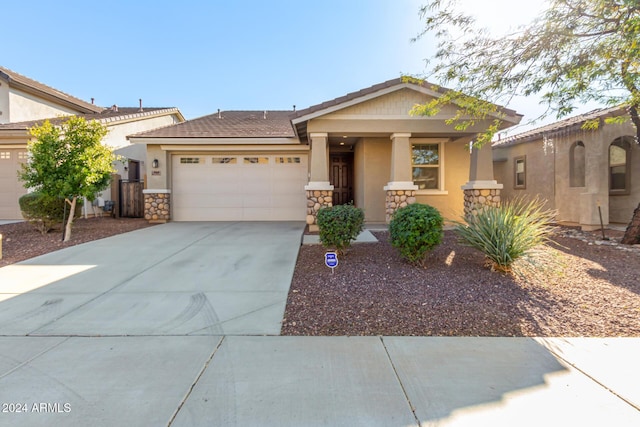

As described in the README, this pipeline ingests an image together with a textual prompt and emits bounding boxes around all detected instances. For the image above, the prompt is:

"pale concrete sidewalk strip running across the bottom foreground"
[0,336,640,427]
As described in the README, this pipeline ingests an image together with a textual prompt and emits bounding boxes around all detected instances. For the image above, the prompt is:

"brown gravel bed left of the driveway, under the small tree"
[0,217,155,267]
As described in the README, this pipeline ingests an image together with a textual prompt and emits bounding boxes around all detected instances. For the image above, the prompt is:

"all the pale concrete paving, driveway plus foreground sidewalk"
[0,222,640,427]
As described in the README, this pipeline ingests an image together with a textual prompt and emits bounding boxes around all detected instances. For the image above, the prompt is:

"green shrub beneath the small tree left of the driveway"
[18,192,82,234]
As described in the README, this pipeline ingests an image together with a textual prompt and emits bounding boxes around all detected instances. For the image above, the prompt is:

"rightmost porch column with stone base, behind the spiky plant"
[462,143,503,218]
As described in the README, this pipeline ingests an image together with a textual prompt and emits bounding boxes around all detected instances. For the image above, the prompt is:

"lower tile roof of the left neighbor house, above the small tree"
[0,107,182,131]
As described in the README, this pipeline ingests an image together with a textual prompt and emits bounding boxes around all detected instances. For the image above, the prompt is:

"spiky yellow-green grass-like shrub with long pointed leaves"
[455,198,555,272]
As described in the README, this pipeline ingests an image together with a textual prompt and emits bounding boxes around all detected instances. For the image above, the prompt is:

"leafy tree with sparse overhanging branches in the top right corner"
[412,0,640,242]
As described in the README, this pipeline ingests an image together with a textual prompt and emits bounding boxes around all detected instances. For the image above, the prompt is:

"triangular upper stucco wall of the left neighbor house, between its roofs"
[7,84,78,123]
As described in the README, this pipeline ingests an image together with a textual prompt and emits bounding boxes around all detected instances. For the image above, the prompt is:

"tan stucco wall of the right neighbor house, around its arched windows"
[493,119,640,225]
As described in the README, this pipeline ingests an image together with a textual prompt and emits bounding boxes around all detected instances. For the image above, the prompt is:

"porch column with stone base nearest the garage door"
[304,133,333,231]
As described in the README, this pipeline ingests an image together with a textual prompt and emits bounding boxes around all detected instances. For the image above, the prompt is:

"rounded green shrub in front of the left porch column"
[318,204,364,253]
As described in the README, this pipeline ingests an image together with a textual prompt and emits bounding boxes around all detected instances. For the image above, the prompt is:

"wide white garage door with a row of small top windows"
[171,154,307,221]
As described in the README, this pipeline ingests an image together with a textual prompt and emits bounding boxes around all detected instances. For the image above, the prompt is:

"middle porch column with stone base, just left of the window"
[384,133,418,223]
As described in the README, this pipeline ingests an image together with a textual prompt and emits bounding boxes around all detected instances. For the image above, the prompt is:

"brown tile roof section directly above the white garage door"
[133,110,296,138]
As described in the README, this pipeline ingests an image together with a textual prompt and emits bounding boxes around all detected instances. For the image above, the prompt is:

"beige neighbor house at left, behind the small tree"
[0,67,184,219]
